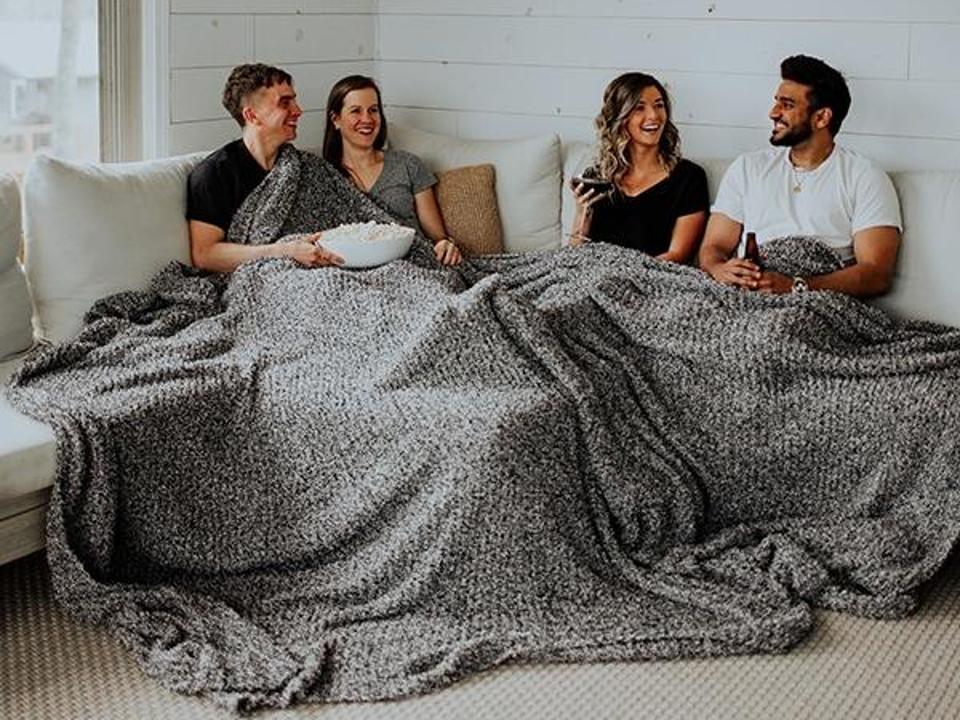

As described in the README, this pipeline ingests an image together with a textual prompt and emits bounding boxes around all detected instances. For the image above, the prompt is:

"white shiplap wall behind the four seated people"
[169,0,960,169]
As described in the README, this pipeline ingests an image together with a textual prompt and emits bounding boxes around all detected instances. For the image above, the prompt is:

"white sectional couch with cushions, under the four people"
[0,127,960,563]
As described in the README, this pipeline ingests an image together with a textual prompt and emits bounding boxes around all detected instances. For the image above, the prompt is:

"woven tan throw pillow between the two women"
[436,164,503,255]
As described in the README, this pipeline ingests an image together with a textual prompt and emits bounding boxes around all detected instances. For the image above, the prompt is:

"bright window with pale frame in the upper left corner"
[0,0,149,175]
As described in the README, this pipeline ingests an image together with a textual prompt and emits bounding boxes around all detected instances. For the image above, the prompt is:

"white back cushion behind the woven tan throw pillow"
[390,125,560,252]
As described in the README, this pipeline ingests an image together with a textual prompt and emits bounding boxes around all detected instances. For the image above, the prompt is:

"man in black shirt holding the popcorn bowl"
[187,63,343,272]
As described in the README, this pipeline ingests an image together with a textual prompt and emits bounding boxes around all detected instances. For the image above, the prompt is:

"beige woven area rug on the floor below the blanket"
[0,553,960,720]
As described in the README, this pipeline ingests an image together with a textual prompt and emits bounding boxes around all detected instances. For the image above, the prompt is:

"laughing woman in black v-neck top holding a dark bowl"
[570,73,710,263]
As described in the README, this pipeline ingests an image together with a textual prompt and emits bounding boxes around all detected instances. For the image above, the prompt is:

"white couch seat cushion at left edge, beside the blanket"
[0,361,57,502]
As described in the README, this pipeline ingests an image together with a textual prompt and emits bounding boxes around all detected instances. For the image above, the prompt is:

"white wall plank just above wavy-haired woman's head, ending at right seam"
[379,15,909,78]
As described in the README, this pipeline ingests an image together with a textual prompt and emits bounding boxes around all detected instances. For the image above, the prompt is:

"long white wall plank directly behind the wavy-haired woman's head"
[379,62,960,140]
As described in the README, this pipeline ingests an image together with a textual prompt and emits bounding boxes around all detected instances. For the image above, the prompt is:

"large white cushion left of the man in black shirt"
[24,154,202,341]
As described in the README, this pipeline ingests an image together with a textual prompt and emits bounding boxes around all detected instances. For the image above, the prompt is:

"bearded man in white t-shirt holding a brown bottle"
[700,55,901,296]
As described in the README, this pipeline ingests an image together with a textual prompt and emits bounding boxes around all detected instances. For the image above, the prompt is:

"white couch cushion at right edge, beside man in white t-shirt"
[876,170,960,327]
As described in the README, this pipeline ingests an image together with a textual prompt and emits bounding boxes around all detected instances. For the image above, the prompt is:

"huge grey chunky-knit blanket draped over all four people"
[9,148,960,711]
